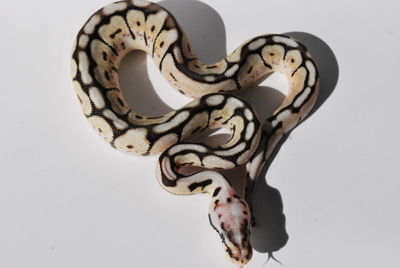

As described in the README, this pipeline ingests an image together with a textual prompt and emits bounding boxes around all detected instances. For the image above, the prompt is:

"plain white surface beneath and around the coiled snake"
[0,0,400,268]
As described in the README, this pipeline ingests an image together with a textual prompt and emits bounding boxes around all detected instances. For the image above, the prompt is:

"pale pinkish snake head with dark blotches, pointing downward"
[209,195,252,265]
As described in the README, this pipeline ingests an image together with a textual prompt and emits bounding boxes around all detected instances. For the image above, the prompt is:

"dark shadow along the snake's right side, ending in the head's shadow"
[250,32,339,253]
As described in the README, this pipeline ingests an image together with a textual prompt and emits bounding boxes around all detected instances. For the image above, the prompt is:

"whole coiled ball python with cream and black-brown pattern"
[71,0,319,265]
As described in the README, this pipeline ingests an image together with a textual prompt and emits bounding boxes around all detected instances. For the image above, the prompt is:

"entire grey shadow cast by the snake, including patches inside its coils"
[119,0,339,260]
